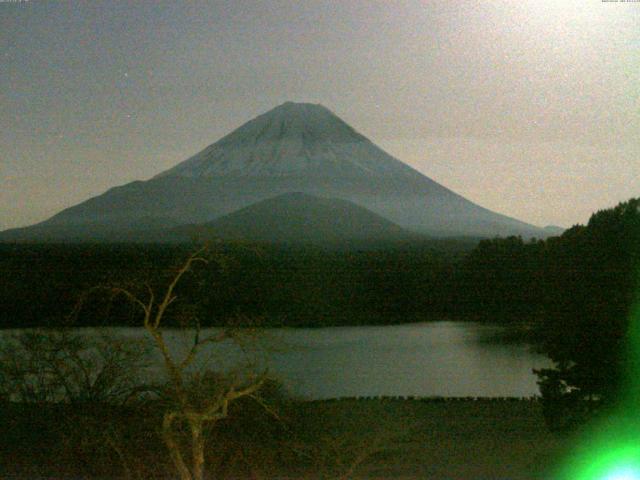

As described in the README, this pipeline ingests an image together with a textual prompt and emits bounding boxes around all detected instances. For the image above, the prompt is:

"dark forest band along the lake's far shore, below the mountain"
[0,241,474,328]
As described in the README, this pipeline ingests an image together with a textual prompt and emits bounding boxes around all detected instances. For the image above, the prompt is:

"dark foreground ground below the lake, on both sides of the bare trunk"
[0,399,567,480]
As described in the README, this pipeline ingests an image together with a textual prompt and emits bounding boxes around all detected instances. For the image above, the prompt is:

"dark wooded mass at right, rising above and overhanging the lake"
[450,199,640,430]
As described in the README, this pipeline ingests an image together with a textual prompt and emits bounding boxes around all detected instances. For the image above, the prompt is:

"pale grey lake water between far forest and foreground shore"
[0,322,549,399]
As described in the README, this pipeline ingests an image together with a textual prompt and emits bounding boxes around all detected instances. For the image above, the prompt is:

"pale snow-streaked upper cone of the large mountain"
[158,102,420,177]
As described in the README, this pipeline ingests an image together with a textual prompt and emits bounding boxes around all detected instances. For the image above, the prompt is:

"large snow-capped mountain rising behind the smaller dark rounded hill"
[0,102,548,241]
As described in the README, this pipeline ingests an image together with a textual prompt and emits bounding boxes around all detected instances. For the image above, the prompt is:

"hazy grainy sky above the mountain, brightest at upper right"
[0,0,640,229]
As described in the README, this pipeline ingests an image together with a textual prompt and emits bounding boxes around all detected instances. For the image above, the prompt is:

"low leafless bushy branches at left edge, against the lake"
[0,328,146,404]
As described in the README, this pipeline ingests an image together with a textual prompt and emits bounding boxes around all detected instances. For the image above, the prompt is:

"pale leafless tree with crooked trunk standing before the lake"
[112,247,266,480]
